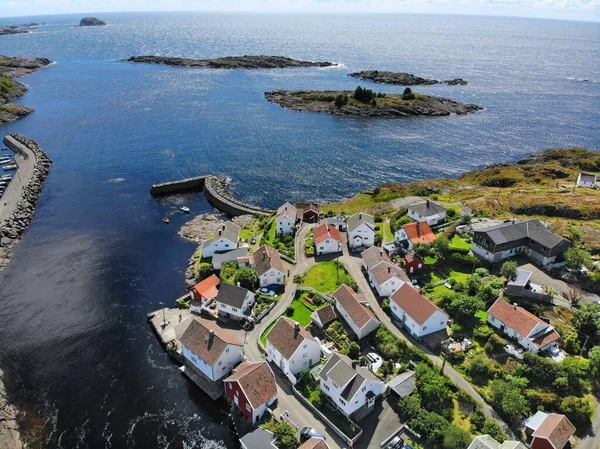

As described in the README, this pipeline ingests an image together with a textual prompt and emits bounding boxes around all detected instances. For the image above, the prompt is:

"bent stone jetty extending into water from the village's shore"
[150,175,275,217]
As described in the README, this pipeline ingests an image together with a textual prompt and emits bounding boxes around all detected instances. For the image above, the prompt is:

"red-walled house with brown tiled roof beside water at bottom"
[223,361,277,423]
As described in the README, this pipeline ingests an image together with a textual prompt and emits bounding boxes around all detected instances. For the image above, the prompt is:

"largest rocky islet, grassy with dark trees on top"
[265,86,483,118]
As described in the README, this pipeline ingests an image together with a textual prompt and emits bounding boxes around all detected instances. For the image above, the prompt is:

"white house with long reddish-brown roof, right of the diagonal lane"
[390,284,448,339]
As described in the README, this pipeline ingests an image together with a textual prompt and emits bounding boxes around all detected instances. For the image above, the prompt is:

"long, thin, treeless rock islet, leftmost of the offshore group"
[126,55,336,69]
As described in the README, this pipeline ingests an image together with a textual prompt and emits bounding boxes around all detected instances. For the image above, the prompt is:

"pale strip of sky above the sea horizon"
[0,0,600,22]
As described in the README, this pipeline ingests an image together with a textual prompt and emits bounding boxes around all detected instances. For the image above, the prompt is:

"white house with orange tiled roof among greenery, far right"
[487,298,560,354]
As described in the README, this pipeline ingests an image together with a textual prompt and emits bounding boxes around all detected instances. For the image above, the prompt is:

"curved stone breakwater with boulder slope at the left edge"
[0,134,52,270]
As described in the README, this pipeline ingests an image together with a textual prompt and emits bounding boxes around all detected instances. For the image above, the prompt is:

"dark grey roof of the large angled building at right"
[478,219,566,248]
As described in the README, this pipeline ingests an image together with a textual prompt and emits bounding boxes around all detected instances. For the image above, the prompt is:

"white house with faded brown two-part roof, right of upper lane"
[361,246,410,298]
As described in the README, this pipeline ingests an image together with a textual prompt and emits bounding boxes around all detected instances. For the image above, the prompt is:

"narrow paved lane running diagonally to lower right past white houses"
[340,245,512,434]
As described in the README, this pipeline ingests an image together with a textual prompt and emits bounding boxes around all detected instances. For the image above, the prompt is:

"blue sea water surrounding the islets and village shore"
[0,13,600,448]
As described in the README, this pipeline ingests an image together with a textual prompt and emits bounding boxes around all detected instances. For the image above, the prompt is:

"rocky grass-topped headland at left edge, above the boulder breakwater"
[0,55,52,125]
